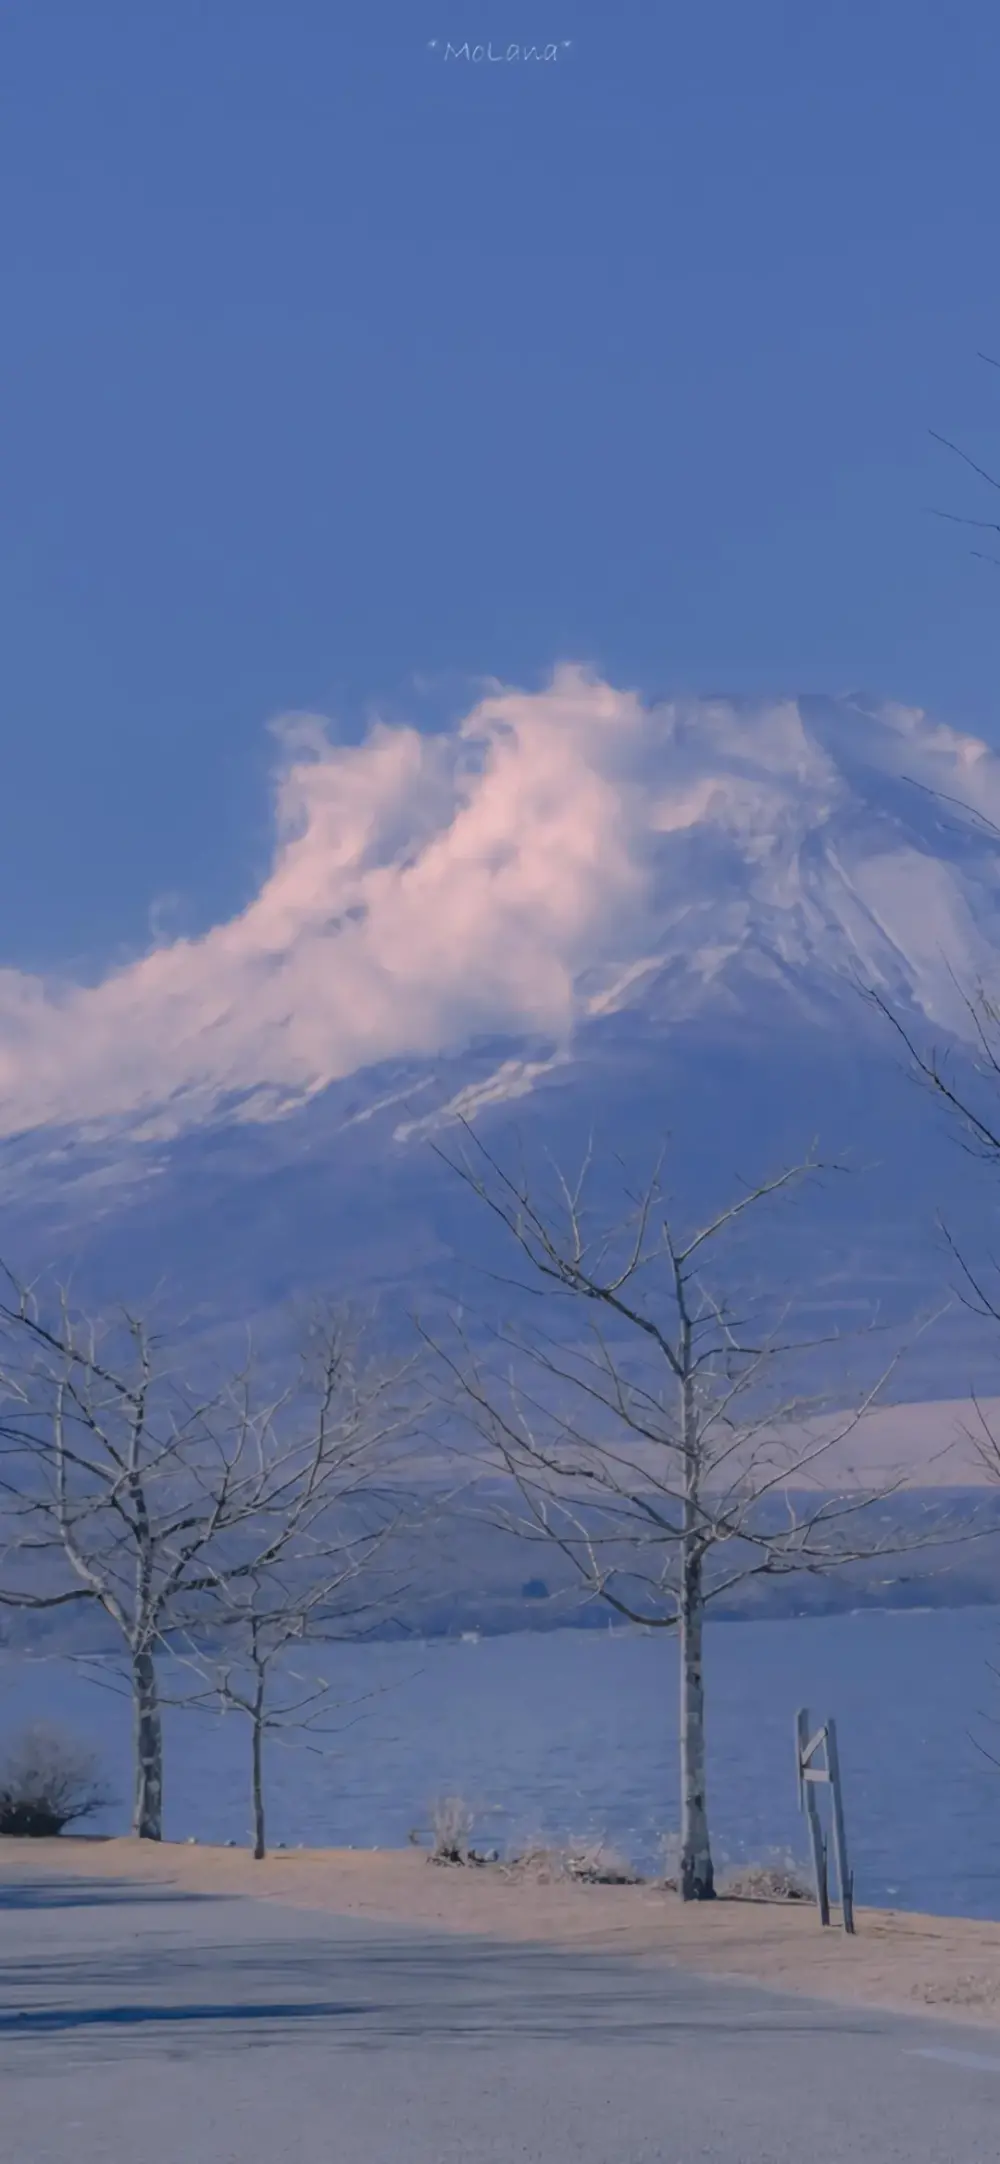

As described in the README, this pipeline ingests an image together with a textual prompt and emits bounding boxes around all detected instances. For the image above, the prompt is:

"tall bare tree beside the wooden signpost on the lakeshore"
[424,1127,942,1900]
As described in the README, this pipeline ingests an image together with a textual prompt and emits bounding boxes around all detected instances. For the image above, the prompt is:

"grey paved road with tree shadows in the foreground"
[0,1872,1000,2164]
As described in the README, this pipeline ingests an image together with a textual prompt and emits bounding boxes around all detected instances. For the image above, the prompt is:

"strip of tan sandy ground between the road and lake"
[0,1835,1000,2028]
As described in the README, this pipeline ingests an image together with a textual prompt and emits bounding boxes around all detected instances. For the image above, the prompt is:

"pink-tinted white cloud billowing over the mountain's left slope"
[0,669,658,1134]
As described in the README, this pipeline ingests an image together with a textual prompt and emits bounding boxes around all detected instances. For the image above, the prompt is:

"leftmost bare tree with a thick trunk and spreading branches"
[0,1272,422,1839]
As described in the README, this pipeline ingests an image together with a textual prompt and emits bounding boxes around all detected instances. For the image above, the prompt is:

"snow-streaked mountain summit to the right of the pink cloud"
[567,699,1000,1030]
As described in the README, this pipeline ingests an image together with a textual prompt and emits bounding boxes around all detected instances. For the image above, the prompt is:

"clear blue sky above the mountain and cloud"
[0,0,1000,974]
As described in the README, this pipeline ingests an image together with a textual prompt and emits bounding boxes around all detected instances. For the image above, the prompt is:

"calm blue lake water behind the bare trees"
[0,1608,1000,1917]
